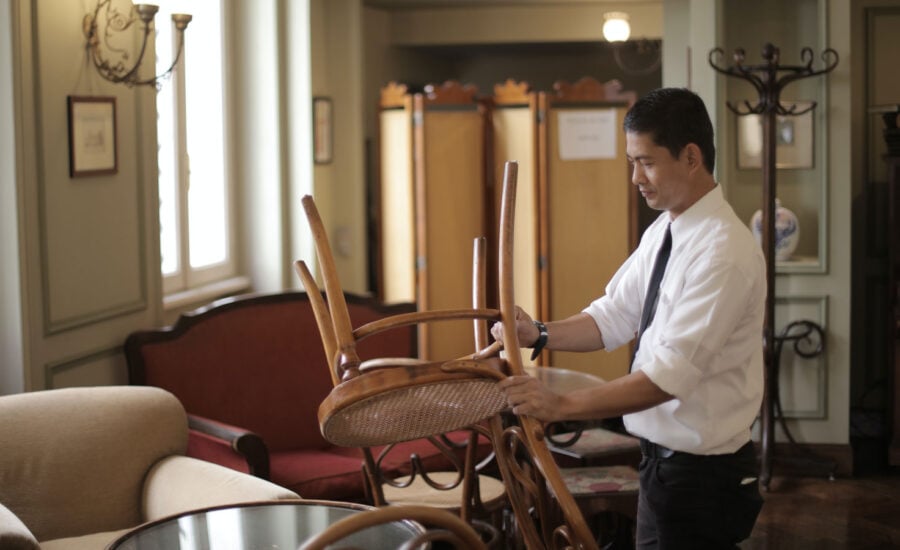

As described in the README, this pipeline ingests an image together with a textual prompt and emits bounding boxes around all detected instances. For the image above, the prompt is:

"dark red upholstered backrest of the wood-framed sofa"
[125,291,415,452]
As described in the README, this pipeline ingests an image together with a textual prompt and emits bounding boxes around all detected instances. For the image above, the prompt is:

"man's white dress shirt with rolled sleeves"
[584,185,766,454]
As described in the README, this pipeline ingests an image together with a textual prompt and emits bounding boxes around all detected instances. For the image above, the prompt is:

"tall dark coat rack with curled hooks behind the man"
[709,43,838,489]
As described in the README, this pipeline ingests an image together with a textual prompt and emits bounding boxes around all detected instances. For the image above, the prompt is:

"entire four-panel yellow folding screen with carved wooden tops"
[379,78,637,379]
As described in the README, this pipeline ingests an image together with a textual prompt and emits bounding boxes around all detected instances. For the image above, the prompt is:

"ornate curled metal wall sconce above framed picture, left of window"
[82,0,192,89]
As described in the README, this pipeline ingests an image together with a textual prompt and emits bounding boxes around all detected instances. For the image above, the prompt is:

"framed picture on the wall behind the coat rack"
[737,101,815,169]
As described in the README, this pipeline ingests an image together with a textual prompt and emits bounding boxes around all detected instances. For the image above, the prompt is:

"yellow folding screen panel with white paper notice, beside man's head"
[538,79,637,380]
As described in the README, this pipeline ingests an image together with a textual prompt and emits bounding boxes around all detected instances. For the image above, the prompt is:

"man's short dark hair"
[622,88,716,174]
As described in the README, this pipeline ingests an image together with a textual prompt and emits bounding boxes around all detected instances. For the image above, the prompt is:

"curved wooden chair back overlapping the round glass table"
[300,506,487,550]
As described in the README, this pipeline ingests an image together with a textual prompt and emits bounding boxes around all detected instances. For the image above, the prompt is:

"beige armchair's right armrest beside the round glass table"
[142,456,300,521]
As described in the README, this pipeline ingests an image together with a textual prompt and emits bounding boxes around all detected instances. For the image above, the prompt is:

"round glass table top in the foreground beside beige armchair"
[108,500,423,550]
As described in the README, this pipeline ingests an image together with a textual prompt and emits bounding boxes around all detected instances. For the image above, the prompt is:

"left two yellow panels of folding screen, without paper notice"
[379,82,488,359]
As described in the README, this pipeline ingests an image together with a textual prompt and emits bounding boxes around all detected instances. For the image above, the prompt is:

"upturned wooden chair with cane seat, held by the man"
[296,168,515,447]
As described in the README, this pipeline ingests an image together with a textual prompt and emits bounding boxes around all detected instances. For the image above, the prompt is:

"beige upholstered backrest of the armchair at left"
[0,386,188,541]
